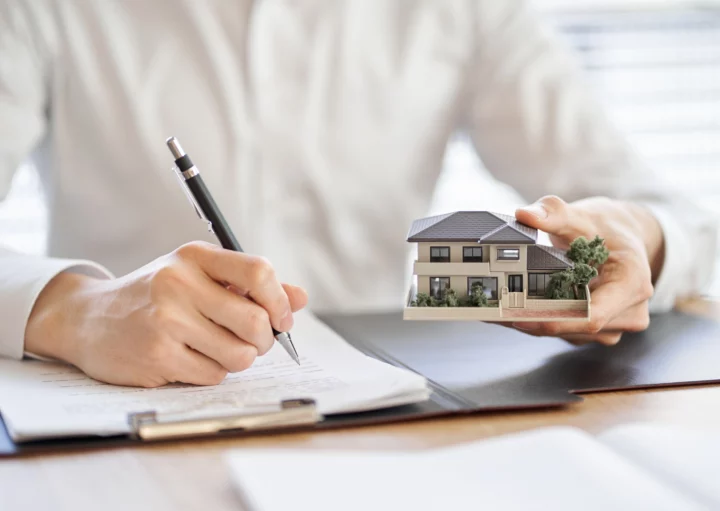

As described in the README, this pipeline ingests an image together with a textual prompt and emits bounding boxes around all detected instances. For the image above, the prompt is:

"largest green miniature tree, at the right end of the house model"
[545,236,610,300]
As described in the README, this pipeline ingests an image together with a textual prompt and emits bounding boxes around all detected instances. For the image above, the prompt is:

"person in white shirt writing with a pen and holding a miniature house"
[0,0,717,386]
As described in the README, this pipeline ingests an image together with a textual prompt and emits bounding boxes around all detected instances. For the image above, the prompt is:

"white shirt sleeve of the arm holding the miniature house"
[465,0,718,312]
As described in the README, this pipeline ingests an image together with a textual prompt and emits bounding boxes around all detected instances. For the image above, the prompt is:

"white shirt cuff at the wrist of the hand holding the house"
[645,204,693,313]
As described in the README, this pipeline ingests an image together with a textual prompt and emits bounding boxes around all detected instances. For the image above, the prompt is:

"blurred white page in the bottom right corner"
[599,423,720,509]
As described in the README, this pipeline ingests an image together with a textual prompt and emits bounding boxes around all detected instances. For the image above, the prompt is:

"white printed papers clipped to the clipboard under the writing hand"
[0,313,429,441]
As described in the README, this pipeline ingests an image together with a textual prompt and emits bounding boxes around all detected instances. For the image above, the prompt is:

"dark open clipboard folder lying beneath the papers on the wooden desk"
[0,312,720,456]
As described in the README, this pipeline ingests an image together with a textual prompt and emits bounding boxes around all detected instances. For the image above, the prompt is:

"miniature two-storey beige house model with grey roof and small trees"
[403,211,608,322]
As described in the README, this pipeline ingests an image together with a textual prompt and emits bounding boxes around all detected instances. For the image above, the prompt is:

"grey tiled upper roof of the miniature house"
[407,211,537,244]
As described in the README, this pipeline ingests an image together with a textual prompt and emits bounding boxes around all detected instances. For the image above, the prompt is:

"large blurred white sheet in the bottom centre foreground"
[228,428,705,511]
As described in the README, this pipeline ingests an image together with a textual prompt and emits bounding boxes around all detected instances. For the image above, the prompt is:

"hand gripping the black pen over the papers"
[25,151,307,387]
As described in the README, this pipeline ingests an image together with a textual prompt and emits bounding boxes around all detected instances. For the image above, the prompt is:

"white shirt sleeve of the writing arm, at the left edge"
[0,0,110,358]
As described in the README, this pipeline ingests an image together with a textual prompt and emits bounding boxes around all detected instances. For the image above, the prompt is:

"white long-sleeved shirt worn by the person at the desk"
[0,0,716,357]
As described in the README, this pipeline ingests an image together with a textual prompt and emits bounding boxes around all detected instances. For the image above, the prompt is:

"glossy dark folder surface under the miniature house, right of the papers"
[323,312,720,404]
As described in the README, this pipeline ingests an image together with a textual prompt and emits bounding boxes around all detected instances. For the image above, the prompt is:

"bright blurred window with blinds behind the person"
[0,0,720,297]
